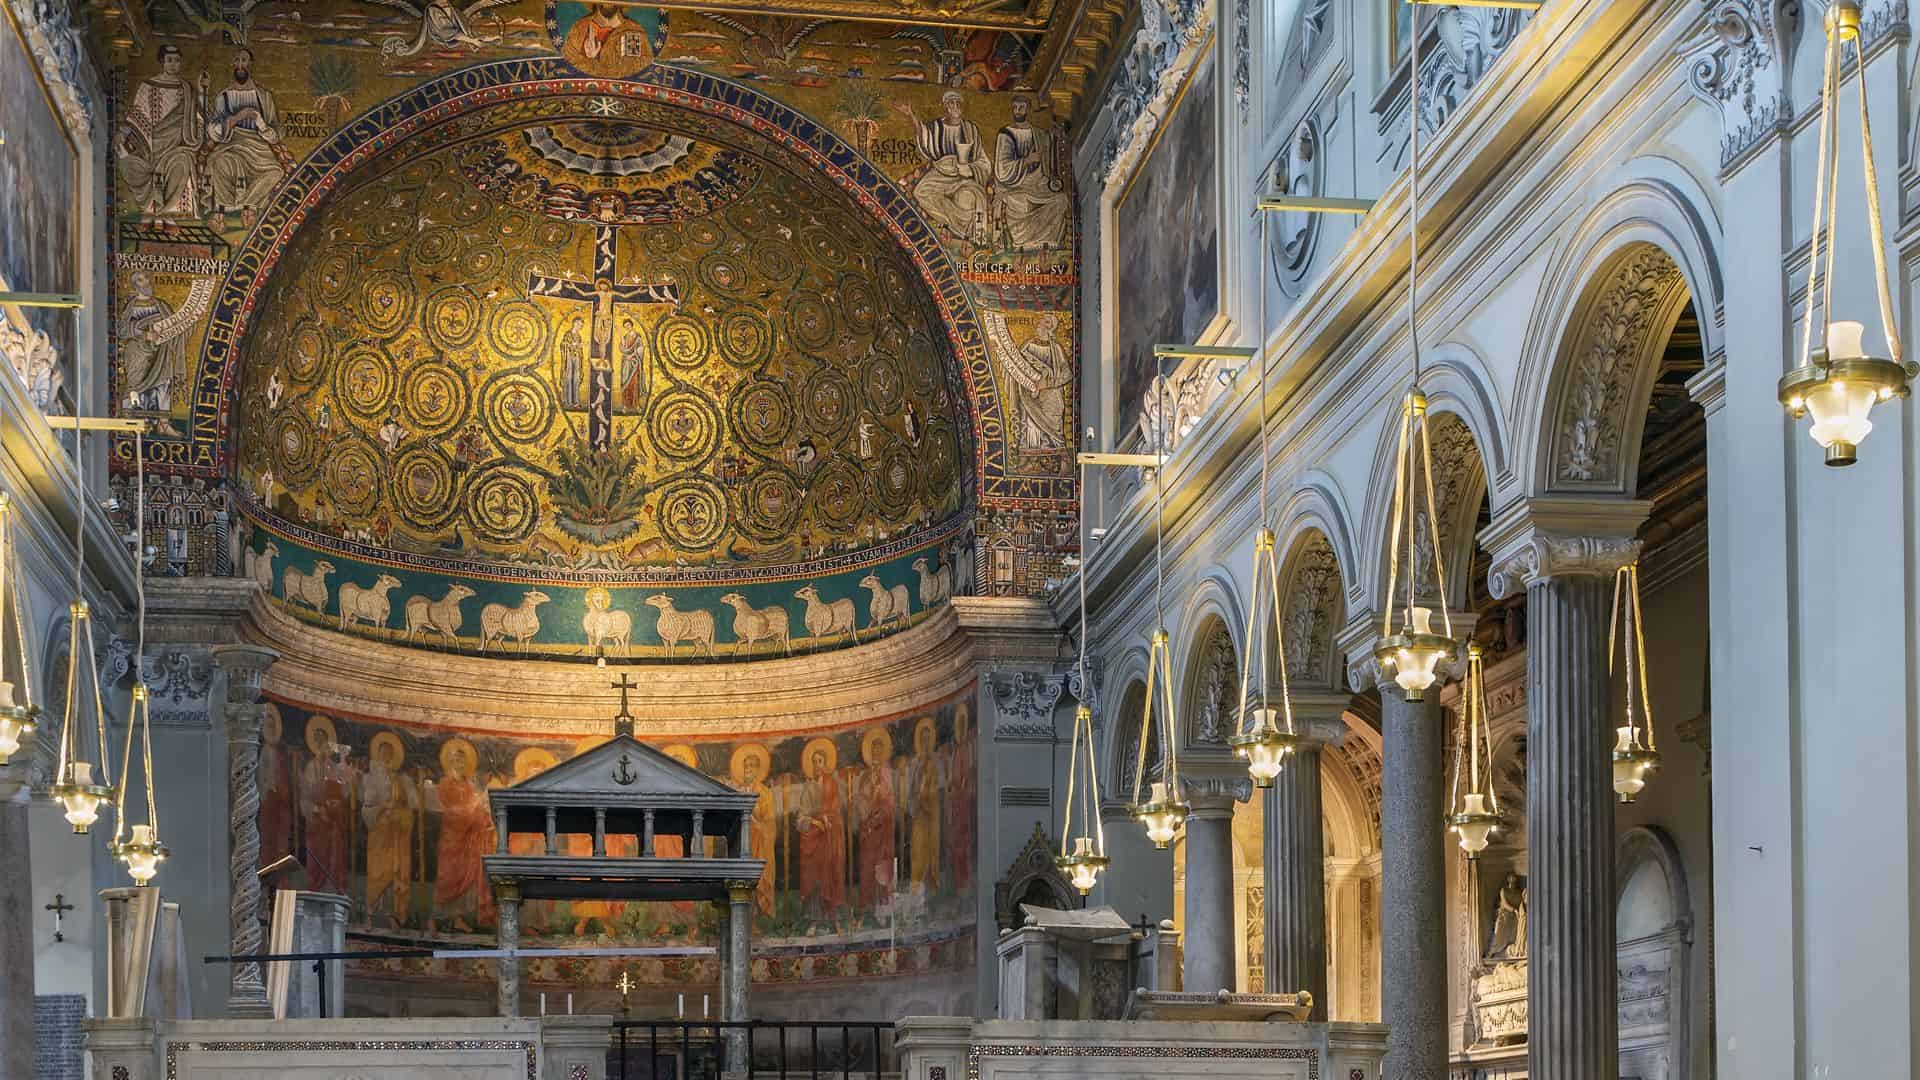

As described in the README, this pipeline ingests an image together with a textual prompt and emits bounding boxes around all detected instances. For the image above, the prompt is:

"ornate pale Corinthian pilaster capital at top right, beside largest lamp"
[1680,0,1801,171]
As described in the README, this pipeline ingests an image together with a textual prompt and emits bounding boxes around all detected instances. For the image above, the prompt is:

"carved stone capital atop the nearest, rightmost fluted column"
[1480,496,1653,600]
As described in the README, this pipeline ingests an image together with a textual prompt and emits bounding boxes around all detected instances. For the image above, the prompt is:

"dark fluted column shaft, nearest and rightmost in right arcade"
[1526,575,1620,1080]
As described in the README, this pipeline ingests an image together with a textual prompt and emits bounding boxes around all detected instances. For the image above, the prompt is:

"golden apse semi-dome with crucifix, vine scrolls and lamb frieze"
[234,96,970,659]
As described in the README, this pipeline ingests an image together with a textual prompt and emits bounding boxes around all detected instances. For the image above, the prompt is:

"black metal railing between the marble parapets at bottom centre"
[607,1020,899,1080]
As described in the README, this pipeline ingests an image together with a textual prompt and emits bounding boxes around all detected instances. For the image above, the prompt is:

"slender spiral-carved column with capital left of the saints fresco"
[213,646,280,1019]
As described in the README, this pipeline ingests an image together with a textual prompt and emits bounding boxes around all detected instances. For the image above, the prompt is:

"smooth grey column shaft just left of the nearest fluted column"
[1380,668,1443,1080]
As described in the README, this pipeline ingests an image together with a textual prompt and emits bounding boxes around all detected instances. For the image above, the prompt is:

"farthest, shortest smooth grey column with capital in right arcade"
[1181,773,1254,994]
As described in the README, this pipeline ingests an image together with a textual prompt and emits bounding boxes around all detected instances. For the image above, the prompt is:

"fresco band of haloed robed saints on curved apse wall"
[259,686,977,986]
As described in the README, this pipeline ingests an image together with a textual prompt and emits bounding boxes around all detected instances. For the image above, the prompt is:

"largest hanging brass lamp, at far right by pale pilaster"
[1780,0,1920,467]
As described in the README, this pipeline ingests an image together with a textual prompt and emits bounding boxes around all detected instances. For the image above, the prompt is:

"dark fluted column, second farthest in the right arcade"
[1261,701,1346,1022]
